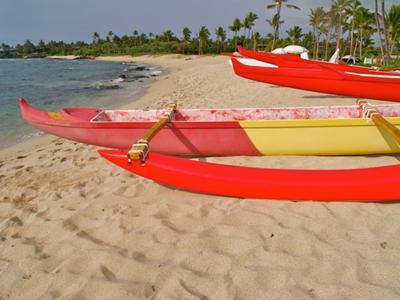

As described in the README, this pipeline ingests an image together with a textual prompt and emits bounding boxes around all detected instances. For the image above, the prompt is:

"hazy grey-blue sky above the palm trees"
[0,0,399,45]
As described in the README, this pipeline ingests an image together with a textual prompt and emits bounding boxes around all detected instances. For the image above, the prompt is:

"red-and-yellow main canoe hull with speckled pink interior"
[20,99,400,156]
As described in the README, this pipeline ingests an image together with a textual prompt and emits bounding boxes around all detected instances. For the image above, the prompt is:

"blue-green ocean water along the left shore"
[0,59,159,148]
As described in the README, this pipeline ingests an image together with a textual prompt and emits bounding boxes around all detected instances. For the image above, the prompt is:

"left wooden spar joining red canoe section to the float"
[128,103,177,161]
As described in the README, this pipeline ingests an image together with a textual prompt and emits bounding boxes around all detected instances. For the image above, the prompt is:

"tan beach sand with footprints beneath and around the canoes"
[0,55,400,299]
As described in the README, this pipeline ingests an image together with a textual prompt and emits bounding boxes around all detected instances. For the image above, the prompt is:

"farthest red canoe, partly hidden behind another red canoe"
[238,47,400,77]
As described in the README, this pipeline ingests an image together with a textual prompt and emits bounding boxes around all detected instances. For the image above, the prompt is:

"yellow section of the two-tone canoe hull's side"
[239,118,400,155]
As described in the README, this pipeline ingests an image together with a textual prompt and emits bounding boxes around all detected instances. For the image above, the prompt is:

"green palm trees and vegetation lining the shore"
[0,0,400,65]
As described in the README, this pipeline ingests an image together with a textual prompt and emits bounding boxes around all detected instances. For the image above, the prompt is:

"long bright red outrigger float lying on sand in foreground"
[99,150,400,201]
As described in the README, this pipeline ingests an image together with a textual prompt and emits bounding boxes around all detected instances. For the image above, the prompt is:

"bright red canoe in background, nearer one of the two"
[231,57,400,101]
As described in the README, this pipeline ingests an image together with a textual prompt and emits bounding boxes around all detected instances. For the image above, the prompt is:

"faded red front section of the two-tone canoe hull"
[20,99,261,156]
